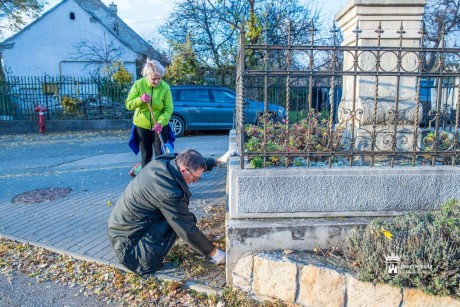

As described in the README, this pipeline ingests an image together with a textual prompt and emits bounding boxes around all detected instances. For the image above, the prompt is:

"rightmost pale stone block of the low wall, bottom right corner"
[401,289,460,307]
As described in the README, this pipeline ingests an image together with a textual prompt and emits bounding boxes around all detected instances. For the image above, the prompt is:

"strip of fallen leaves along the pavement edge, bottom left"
[0,238,279,306]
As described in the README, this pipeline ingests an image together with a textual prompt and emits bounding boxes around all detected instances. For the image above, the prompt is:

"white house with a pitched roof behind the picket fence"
[1,0,165,77]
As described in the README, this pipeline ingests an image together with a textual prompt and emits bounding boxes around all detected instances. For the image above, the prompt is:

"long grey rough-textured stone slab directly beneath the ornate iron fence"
[228,164,460,219]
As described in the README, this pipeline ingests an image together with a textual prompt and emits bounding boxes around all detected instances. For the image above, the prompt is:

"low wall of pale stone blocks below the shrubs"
[232,251,460,307]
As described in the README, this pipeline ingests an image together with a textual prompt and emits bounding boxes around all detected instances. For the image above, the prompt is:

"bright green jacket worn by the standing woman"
[125,78,174,129]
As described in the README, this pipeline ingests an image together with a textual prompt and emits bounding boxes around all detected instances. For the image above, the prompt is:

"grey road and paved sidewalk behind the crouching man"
[0,132,228,287]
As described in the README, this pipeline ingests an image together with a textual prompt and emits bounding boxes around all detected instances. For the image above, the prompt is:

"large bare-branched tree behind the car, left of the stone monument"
[160,0,318,83]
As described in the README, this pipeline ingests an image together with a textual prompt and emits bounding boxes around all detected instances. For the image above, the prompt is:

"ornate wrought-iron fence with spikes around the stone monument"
[236,24,460,168]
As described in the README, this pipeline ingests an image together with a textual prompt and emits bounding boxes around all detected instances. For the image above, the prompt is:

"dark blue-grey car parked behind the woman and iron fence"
[169,85,286,136]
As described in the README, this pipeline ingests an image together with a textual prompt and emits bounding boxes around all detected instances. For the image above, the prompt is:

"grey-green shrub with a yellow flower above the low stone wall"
[345,200,460,297]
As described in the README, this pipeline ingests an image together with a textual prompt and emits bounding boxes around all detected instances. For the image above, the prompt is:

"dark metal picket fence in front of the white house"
[0,76,132,120]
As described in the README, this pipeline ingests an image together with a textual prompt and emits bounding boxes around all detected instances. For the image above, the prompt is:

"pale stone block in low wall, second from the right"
[347,276,402,307]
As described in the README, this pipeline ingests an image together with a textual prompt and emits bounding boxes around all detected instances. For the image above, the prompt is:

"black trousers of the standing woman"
[136,125,169,167]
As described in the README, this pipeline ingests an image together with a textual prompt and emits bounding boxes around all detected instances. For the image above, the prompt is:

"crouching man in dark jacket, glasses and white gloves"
[108,149,228,276]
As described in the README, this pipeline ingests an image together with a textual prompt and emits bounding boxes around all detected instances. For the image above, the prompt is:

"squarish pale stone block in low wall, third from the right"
[297,265,347,306]
